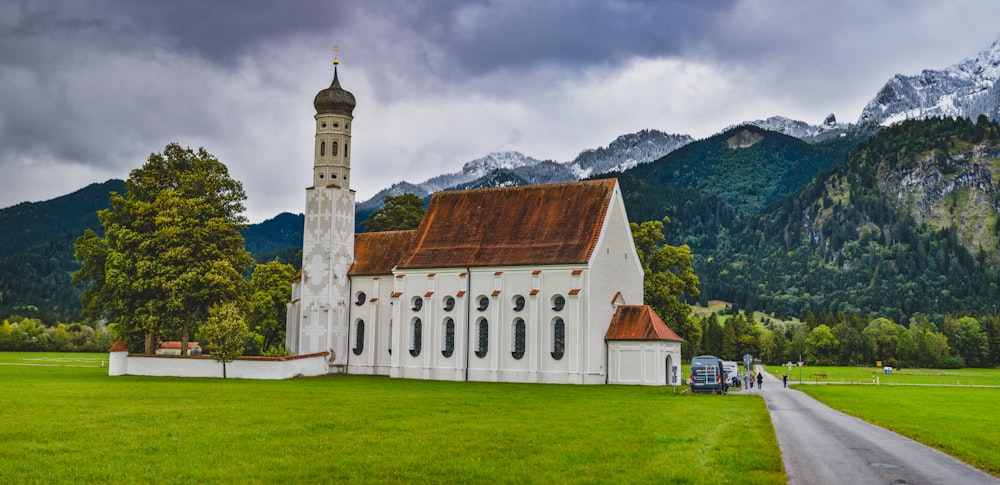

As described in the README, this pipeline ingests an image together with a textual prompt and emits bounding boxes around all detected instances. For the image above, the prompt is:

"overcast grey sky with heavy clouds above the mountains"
[0,0,1000,222]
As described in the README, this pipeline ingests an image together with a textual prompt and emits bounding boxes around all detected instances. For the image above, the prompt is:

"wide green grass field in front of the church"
[0,353,786,484]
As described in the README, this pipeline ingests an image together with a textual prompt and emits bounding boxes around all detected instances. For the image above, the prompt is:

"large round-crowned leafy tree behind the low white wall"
[73,144,252,353]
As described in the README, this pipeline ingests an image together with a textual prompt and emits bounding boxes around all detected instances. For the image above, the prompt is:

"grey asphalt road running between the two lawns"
[751,368,1000,485]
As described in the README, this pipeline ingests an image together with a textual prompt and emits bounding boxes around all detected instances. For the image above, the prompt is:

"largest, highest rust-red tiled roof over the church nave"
[399,179,618,269]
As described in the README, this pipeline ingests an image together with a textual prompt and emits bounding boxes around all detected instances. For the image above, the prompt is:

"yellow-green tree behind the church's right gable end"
[629,217,700,328]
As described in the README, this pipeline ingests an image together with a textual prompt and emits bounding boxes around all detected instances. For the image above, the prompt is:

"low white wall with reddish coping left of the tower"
[108,352,329,380]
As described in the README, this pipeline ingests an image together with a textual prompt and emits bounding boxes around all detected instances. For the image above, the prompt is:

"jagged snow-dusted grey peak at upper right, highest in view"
[859,38,1000,125]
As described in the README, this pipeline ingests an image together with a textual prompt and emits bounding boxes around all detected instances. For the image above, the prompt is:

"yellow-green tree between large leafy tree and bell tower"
[249,261,295,352]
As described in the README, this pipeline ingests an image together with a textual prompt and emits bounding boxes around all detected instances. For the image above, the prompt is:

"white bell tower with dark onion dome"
[286,47,355,372]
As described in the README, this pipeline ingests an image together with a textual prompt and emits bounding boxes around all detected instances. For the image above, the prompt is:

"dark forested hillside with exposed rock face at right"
[682,118,1000,323]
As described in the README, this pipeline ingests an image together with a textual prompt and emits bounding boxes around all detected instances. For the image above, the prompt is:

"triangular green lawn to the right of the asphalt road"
[796,384,1000,477]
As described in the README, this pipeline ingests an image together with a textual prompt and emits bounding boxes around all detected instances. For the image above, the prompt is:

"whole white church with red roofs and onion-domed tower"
[286,60,682,385]
